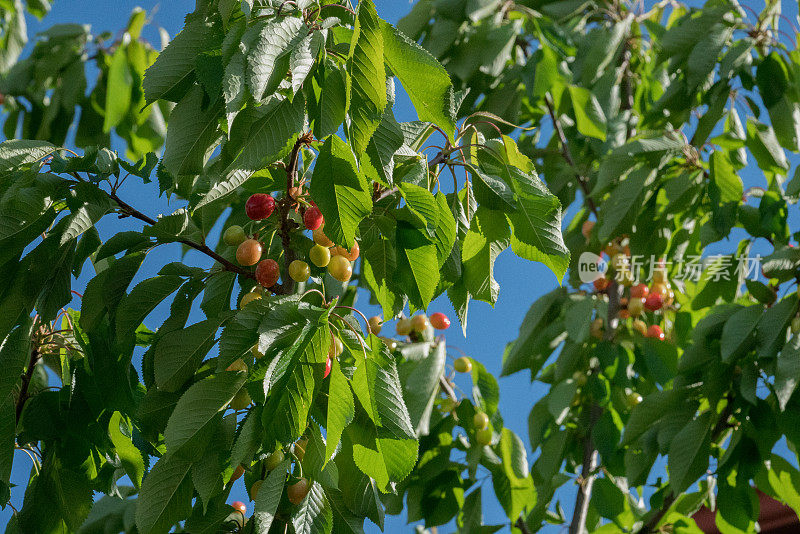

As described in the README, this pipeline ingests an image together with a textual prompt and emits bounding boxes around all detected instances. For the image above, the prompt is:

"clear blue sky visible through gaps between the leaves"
[0,0,797,532]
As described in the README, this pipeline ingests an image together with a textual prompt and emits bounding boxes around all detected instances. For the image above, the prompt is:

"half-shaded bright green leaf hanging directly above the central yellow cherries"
[311,135,372,250]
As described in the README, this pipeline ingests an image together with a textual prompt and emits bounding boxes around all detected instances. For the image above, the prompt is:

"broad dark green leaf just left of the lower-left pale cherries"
[164,372,246,459]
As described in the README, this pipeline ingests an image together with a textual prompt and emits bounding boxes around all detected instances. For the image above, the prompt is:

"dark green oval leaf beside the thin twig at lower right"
[668,412,711,494]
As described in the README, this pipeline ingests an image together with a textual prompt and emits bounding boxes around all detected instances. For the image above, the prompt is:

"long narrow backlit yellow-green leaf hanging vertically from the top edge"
[347,0,387,154]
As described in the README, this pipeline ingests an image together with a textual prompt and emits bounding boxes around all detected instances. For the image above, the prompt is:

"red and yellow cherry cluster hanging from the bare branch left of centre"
[222,193,359,294]
